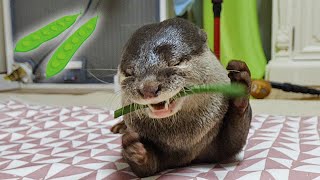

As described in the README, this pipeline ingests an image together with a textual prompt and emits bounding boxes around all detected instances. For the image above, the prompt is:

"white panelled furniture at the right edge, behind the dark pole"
[266,0,320,86]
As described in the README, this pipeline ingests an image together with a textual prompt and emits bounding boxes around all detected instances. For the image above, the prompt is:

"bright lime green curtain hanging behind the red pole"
[203,0,267,79]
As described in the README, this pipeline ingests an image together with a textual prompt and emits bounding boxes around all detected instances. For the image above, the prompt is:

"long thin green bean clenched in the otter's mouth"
[114,83,246,118]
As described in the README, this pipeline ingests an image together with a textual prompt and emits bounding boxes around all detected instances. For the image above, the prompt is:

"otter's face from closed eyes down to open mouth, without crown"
[120,55,187,118]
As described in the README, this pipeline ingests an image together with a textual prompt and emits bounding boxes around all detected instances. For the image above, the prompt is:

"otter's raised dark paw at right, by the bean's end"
[227,60,251,112]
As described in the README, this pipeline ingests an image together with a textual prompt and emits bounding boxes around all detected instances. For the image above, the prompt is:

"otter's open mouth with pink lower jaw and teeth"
[148,99,182,118]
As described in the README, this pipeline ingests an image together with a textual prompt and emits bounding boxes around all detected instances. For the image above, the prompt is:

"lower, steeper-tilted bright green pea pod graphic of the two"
[46,16,98,78]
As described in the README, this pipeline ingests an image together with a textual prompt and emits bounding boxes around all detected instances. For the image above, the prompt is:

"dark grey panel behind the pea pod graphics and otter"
[11,0,159,83]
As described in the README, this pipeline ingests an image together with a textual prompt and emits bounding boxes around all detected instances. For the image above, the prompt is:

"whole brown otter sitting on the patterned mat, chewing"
[111,18,252,177]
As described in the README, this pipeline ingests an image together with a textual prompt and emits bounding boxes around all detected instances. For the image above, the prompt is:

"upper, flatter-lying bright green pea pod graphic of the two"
[15,14,80,52]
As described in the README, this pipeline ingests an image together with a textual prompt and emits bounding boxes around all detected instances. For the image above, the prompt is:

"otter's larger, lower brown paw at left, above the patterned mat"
[122,132,148,166]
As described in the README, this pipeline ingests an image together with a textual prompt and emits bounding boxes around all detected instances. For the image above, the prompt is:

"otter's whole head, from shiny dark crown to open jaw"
[119,19,206,118]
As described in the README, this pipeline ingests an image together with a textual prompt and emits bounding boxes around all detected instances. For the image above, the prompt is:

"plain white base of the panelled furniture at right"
[266,60,320,86]
